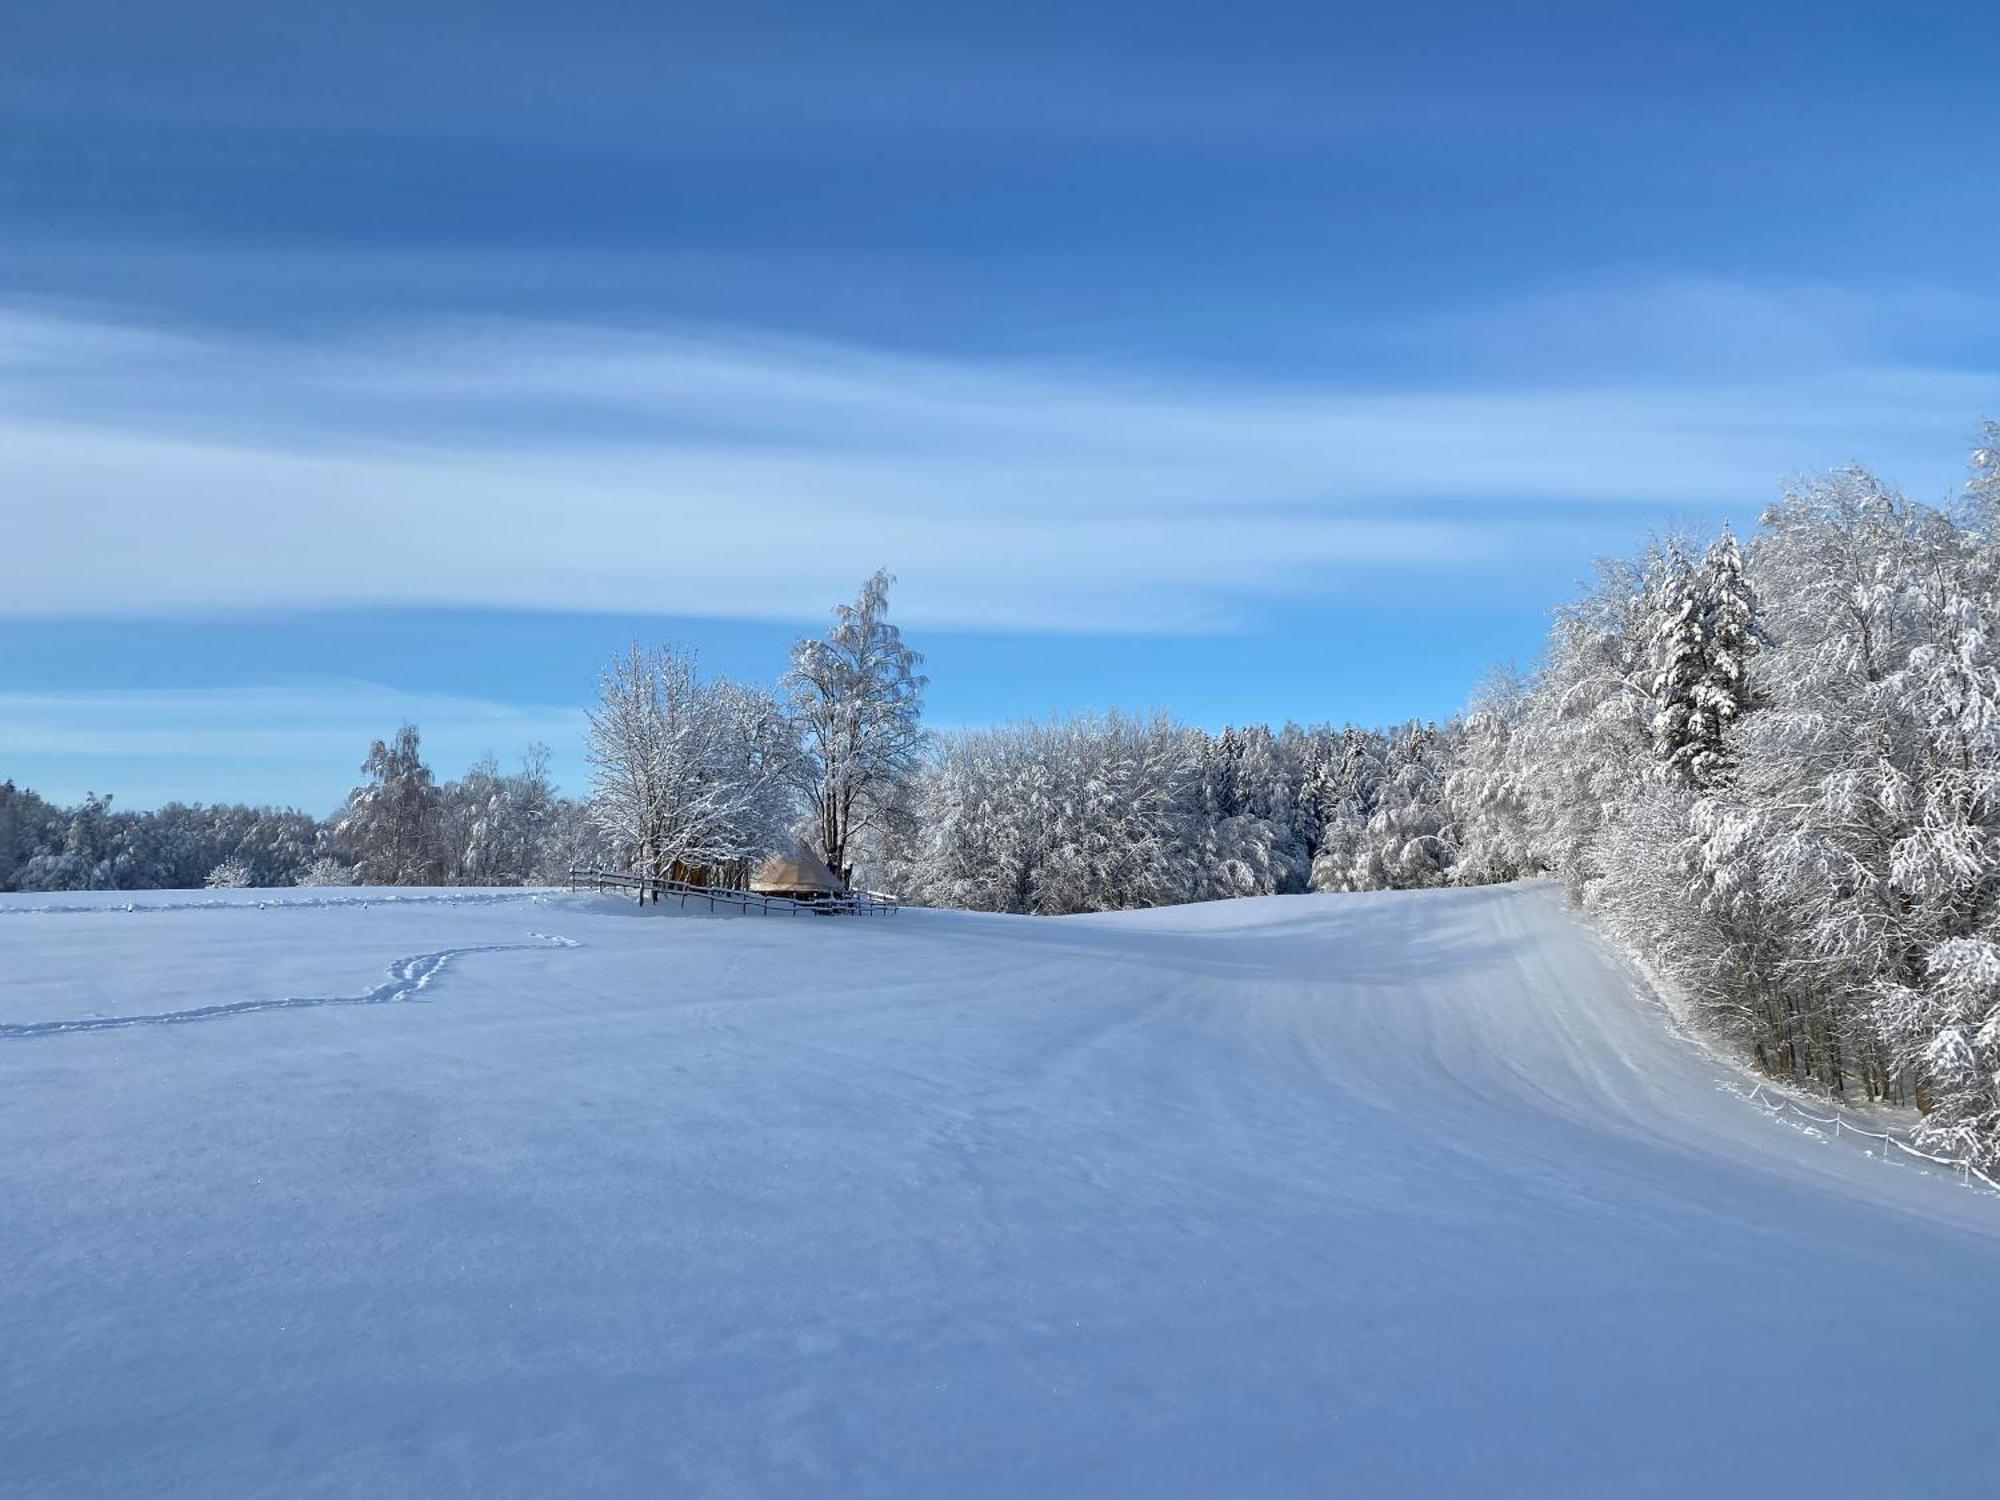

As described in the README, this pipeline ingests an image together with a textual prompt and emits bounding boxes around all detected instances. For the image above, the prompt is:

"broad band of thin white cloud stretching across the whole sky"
[0,302,1996,630]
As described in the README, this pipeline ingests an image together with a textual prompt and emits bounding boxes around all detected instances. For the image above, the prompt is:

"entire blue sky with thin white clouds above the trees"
[0,2,2000,810]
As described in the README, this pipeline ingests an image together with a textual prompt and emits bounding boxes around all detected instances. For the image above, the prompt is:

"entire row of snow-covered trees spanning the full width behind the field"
[11,424,2000,1164]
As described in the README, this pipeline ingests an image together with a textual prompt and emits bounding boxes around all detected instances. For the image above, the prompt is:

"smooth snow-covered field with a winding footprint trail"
[0,886,2000,1500]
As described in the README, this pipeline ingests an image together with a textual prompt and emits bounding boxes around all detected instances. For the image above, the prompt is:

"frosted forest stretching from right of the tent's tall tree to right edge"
[886,424,2000,1166]
